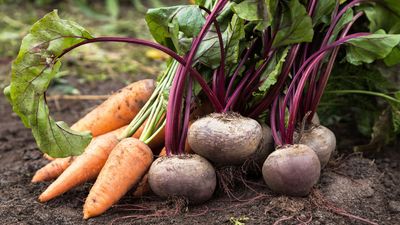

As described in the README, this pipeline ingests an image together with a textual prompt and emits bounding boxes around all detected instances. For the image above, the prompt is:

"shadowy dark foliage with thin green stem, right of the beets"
[318,63,400,152]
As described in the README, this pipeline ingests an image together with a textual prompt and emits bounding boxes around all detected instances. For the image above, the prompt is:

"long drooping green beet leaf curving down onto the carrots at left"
[10,11,92,157]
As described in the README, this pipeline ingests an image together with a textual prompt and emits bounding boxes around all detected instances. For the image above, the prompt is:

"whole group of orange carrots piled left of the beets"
[32,80,163,219]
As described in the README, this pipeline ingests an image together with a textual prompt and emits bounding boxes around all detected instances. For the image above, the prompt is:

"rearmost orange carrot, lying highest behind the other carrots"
[71,79,155,137]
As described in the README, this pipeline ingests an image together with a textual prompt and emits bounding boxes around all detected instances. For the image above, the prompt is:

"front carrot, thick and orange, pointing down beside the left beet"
[83,138,153,219]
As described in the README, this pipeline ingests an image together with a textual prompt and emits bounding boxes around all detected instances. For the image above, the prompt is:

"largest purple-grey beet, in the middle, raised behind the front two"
[188,113,262,165]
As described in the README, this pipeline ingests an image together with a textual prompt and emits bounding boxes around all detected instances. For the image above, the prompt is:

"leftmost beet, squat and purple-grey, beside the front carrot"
[149,154,217,204]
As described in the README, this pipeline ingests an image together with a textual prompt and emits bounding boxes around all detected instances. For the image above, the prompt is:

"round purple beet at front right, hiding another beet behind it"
[262,144,321,196]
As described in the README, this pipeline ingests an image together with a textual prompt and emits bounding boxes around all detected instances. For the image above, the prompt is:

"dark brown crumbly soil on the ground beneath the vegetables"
[0,81,400,224]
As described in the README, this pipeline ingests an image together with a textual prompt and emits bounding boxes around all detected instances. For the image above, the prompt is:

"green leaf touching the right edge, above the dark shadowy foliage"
[346,31,400,65]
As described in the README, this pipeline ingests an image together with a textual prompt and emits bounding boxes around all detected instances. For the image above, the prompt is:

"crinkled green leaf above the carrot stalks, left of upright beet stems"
[146,5,205,52]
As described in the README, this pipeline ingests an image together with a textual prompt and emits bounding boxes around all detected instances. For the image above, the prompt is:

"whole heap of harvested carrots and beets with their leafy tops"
[4,0,400,219]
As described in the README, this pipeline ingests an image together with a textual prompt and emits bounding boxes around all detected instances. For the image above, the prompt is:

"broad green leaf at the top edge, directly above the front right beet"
[272,0,314,47]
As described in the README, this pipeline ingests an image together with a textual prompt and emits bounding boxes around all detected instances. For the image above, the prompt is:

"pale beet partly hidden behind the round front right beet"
[299,125,336,168]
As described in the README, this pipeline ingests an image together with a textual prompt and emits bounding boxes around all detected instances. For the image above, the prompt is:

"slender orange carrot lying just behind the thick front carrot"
[39,129,121,202]
